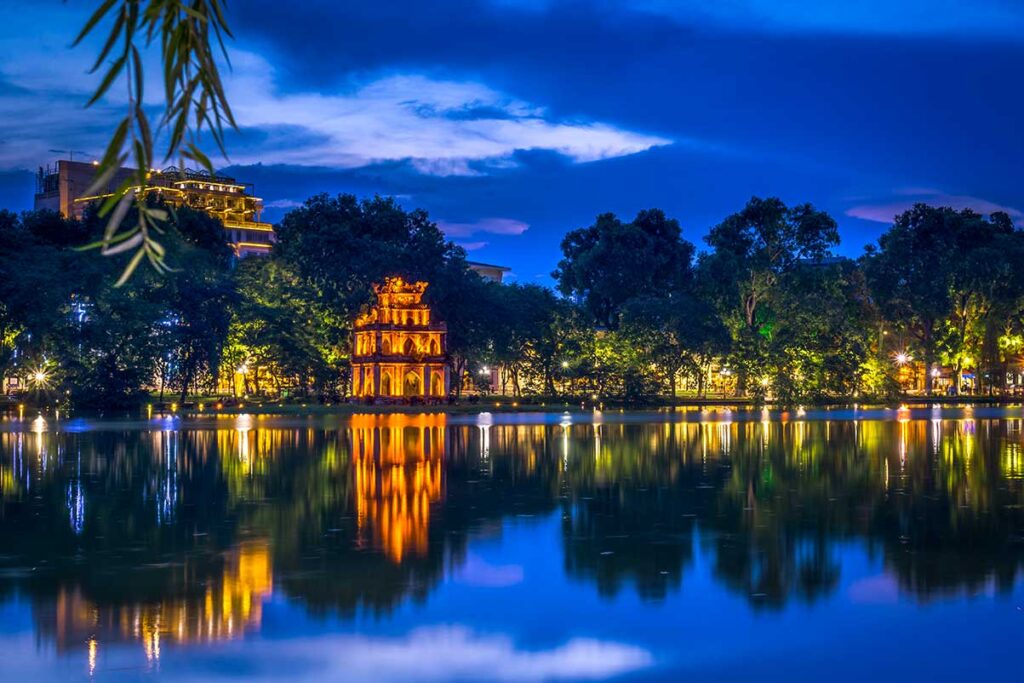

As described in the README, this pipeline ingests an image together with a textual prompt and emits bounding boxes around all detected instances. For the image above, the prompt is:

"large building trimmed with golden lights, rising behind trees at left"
[35,159,274,257]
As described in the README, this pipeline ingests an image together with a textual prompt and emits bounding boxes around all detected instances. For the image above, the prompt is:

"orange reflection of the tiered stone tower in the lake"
[352,415,445,562]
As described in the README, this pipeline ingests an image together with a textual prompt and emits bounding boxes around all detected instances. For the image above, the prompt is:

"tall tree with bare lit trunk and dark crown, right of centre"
[700,197,839,393]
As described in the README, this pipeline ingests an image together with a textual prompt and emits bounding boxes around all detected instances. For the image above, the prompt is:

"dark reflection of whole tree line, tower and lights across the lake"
[0,414,1024,670]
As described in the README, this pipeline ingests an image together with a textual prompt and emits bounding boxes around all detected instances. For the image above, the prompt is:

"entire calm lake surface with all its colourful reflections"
[0,408,1024,683]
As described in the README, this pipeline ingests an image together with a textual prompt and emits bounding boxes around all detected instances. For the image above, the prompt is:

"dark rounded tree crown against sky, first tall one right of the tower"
[552,209,694,330]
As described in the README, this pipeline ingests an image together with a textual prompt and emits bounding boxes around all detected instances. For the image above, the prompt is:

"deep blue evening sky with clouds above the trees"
[0,0,1024,284]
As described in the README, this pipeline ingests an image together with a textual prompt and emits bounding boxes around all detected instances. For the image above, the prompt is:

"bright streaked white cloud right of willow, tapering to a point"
[216,52,671,176]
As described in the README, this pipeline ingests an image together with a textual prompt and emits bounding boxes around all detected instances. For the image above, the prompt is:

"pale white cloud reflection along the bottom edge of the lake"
[37,626,655,683]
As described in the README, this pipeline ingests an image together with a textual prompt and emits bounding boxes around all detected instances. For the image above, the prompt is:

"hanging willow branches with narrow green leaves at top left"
[75,0,234,287]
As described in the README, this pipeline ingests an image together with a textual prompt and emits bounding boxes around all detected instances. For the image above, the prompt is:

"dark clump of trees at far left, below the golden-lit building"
[0,204,233,408]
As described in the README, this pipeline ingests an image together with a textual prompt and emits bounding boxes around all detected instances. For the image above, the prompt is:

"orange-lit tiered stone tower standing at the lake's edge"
[352,278,449,400]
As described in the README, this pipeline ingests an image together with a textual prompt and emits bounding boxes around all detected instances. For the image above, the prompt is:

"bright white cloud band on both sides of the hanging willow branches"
[0,28,672,176]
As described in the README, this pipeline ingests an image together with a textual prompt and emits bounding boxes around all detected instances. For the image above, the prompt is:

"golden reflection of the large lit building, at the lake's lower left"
[34,542,273,673]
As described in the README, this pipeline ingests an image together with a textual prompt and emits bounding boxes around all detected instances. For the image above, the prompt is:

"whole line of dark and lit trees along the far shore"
[0,195,1024,405]
